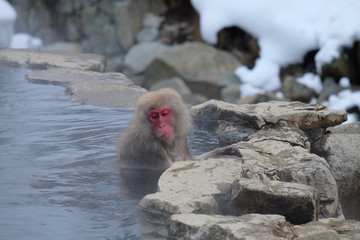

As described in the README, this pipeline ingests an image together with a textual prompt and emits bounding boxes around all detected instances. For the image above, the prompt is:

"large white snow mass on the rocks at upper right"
[191,0,360,96]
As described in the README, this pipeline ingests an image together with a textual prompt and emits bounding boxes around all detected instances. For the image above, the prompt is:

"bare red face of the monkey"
[148,107,174,141]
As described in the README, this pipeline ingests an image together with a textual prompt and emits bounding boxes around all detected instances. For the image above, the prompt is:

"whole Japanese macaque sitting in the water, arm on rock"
[118,89,242,171]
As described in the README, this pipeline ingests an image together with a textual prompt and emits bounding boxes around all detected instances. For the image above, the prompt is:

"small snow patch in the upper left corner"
[0,0,16,48]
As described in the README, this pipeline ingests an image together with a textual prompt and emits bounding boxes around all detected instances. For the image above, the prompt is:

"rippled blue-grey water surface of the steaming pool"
[0,67,218,239]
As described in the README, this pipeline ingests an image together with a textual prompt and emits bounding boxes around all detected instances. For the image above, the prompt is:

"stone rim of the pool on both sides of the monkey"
[0,49,360,239]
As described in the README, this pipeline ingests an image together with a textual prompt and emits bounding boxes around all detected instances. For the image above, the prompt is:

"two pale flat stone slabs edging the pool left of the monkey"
[0,49,146,108]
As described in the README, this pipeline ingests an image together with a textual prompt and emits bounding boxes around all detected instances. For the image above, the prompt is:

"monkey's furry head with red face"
[135,88,192,142]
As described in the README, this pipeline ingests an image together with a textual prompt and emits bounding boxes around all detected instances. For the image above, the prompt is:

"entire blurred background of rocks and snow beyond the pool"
[0,0,360,122]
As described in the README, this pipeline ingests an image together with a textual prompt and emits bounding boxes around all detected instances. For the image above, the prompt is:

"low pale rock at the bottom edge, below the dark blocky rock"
[169,214,296,240]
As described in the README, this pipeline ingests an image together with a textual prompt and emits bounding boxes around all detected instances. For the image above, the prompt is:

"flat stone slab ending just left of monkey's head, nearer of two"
[27,68,147,108]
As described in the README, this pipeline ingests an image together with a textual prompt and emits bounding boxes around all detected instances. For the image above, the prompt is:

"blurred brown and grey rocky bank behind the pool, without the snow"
[10,0,360,117]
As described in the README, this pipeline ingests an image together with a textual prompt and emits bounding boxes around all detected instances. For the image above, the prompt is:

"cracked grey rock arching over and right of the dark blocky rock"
[242,125,341,217]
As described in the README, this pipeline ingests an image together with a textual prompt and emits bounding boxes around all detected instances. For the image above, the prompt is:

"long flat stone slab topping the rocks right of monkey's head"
[191,100,347,130]
